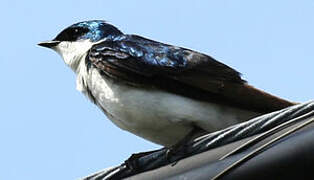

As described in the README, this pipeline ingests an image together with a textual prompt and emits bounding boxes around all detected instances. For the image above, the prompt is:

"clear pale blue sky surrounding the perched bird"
[0,0,314,180]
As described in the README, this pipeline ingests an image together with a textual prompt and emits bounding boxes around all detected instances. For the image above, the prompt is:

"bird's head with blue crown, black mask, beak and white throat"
[38,20,122,70]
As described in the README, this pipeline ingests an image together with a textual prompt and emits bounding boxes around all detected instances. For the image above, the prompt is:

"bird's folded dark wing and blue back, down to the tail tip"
[87,35,291,112]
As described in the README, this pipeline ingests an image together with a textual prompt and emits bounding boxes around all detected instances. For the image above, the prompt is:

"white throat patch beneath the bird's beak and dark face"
[54,40,94,72]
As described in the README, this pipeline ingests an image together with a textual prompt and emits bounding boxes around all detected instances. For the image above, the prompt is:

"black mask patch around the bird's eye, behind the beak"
[55,27,88,41]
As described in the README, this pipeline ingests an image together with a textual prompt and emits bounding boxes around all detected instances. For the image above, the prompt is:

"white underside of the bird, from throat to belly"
[54,40,257,146]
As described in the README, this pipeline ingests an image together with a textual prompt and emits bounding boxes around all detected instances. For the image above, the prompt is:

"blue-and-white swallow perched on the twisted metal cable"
[38,20,295,147]
